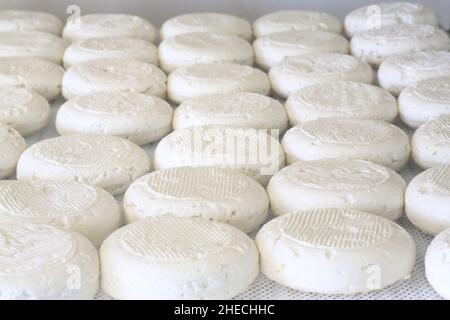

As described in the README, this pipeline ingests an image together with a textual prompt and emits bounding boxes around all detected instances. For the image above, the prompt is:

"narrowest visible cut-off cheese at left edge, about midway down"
[0,123,26,179]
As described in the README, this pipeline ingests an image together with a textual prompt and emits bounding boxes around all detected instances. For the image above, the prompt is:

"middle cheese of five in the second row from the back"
[159,32,254,72]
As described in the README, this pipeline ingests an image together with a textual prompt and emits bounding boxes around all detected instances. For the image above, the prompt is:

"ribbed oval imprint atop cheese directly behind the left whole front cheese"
[146,167,249,199]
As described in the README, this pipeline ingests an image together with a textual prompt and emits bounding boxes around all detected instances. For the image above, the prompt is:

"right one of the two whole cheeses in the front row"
[256,209,416,294]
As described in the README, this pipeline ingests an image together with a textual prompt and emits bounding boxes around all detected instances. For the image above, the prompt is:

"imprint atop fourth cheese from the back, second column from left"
[73,91,162,116]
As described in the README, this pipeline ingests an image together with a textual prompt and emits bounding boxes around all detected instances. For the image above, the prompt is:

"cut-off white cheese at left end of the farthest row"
[0,10,63,36]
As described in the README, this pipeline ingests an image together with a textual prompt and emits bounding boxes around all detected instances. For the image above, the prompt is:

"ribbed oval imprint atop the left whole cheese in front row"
[120,217,234,261]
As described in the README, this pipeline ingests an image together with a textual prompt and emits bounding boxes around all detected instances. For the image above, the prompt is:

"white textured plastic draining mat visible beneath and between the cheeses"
[22,98,441,300]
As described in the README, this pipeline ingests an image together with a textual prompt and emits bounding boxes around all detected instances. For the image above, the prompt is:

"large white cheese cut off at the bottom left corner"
[0,222,100,300]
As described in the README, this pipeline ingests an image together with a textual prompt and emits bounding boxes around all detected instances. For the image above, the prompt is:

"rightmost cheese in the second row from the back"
[350,25,450,65]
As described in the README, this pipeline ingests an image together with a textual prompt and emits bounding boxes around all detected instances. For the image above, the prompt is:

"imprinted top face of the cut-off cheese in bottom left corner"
[0,223,77,276]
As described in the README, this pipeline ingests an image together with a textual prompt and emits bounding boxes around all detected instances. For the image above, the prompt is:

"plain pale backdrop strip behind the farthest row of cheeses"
[0,0,450,29]
